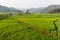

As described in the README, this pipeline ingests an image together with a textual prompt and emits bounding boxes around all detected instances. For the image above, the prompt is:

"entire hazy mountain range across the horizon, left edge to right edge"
[0,5,60,13]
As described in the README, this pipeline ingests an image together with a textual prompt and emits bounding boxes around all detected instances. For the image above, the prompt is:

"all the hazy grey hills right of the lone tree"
[22,5,60,13]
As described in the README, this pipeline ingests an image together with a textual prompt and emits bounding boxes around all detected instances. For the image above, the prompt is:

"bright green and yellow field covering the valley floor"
[0,14,60,40]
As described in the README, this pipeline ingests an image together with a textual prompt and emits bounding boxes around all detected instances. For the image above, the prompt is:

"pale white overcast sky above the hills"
[0,0,60,9]
